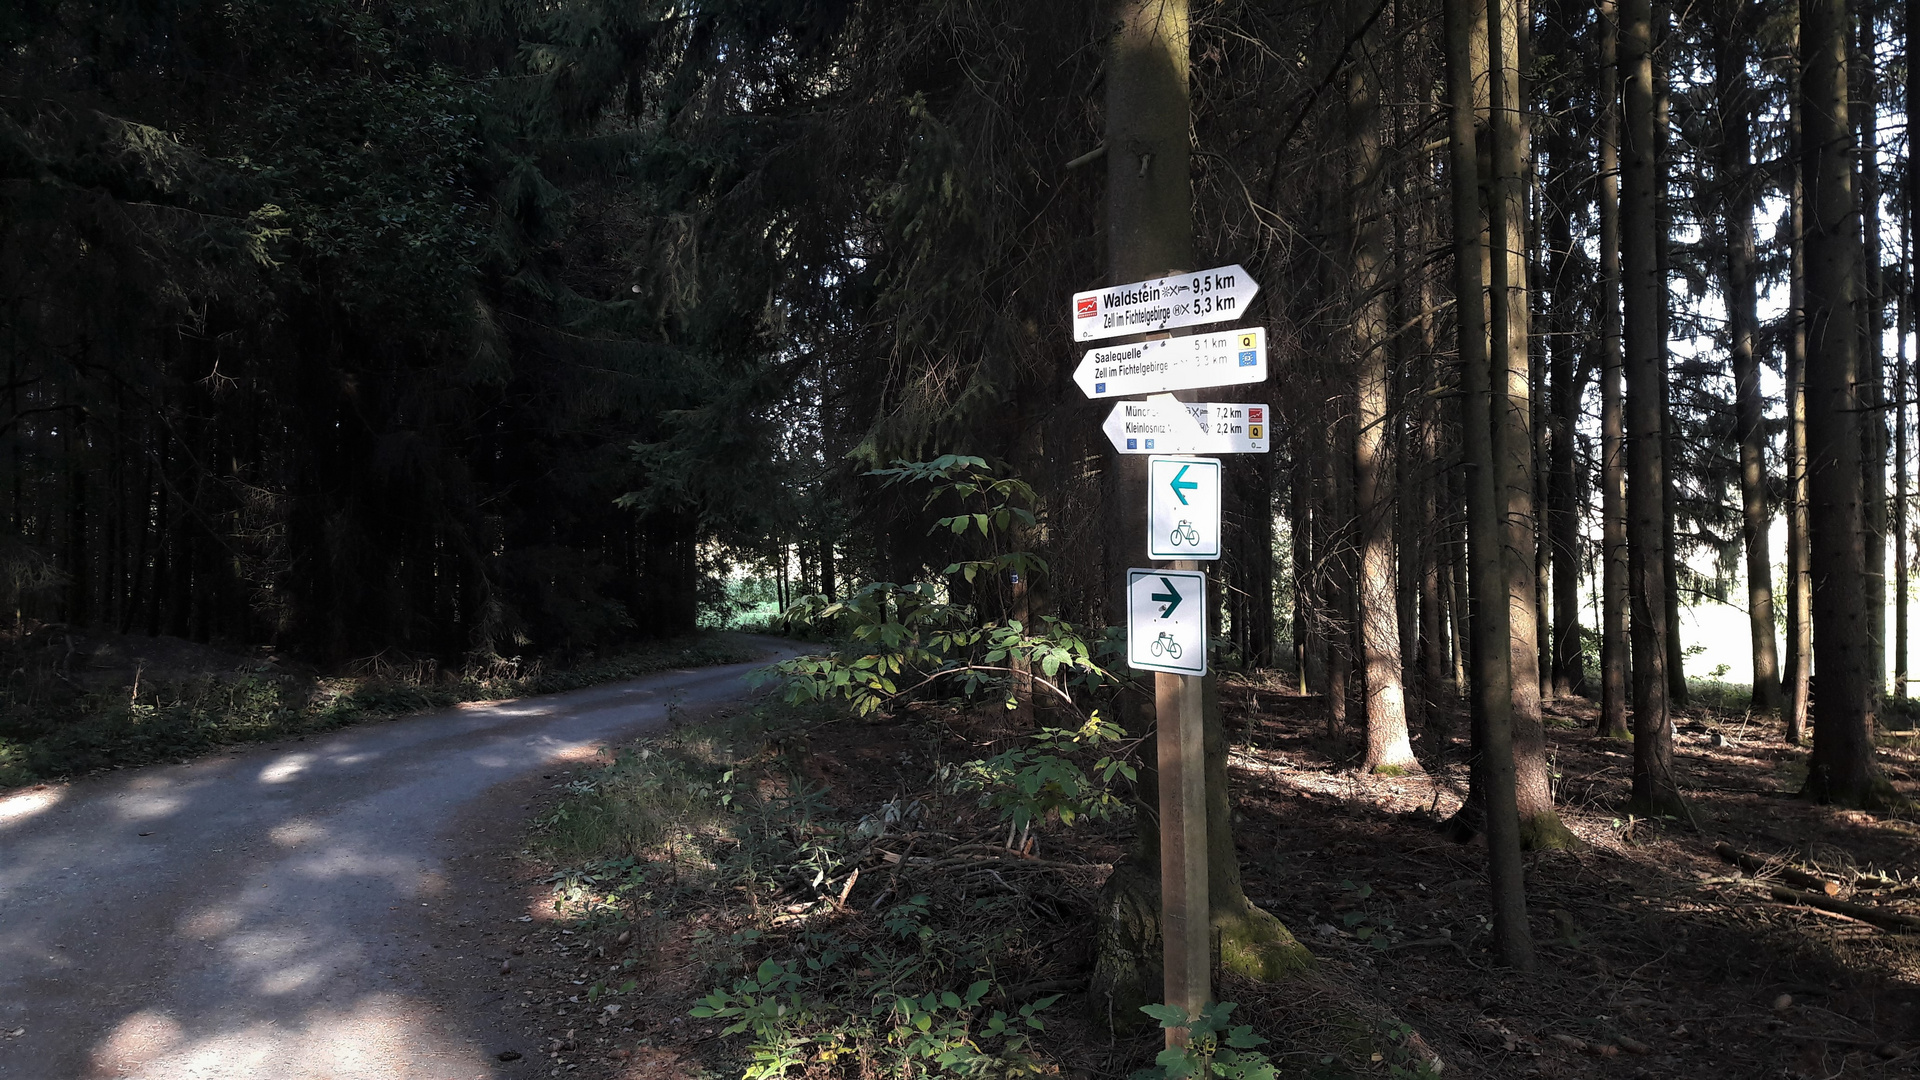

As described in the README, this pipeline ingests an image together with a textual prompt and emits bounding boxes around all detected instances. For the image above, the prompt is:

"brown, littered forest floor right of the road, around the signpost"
[499,676,1920,1080]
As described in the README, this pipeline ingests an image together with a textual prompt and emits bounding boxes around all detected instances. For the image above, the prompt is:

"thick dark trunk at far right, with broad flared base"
[1801,0,1891,807]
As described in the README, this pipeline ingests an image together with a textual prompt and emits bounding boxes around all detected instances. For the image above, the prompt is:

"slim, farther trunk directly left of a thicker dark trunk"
[1597,0,1628,738]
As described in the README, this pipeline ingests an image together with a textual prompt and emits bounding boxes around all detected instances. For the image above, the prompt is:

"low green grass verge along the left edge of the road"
[0,634,762,788]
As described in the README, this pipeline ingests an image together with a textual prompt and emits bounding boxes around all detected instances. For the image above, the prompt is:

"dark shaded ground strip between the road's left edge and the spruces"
[0,626,766,790]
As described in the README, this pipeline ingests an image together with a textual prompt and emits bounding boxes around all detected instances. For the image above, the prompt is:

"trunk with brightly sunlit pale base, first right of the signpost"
[1346,19,1419,774]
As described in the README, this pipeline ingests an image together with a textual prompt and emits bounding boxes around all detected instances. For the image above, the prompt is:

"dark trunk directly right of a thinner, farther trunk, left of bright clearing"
[1620,0,1684,815]
